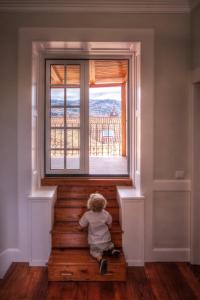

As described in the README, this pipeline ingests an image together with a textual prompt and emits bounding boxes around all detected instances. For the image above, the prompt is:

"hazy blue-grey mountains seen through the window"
[51,99,121,117]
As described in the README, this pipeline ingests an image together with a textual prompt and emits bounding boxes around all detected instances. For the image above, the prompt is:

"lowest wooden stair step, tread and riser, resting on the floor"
[48,249,126,281]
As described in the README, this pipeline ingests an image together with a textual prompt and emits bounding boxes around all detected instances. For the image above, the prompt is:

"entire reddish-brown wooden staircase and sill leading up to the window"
[42,178,132,281]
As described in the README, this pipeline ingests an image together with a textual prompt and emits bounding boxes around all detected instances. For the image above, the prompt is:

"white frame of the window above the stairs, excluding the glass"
[44,53,134,177]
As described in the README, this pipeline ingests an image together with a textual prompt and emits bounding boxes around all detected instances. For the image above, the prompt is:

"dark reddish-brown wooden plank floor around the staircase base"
[0,263,200,300]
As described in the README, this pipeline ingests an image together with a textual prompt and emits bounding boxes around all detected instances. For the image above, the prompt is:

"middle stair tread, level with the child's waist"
[52,222,122,234]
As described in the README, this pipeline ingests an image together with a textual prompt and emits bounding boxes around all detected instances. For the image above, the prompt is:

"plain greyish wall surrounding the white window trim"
[0,13,190,259]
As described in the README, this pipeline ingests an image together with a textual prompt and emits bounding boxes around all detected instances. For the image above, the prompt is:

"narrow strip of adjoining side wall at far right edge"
[190,4,200,264]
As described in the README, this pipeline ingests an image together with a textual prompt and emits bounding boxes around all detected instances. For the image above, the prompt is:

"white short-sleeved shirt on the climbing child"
[79,209,112,245]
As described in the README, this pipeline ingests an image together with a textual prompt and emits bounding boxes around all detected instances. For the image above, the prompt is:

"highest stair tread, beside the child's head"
[55,199,118,207]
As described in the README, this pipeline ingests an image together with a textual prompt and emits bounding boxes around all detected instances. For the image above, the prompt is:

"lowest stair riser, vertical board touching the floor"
[48,263,126,281]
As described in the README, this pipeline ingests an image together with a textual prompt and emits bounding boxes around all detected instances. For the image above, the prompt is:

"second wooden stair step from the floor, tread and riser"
[52,222,122,249]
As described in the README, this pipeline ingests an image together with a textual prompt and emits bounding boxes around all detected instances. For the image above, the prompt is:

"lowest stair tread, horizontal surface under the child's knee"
[48,249,126,266]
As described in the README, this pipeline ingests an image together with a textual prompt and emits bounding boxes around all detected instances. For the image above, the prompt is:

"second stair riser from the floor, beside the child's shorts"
[52,233,122,249]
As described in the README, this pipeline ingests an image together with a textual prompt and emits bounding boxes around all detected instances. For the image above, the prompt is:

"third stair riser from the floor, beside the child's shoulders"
[55,207,119,222]
